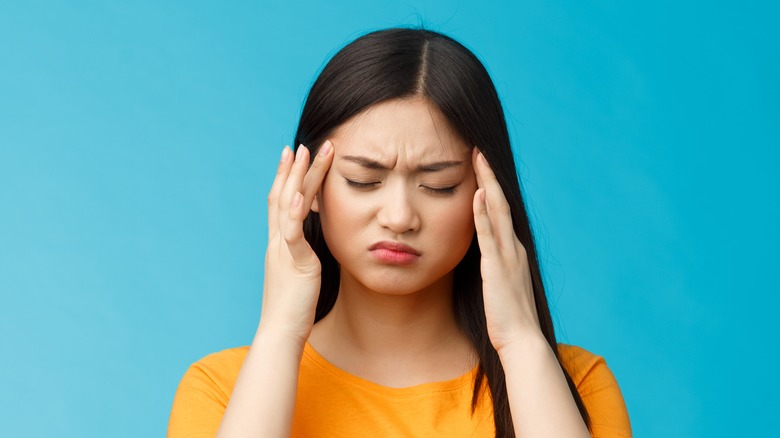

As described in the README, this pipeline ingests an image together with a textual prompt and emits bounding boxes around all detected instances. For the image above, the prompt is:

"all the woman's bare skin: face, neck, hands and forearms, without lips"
[218,98,589,437]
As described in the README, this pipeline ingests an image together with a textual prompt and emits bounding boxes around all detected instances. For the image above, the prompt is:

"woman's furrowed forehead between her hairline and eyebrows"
[331,98,470,164]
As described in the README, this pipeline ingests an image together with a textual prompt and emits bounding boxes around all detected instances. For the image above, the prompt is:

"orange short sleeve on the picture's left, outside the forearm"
[167,348,247,438]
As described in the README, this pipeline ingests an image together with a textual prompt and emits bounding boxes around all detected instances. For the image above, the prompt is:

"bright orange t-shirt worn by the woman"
[168,343,631,438]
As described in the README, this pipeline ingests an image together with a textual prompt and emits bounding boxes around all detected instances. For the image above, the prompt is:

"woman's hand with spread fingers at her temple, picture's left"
[258,141,333,348]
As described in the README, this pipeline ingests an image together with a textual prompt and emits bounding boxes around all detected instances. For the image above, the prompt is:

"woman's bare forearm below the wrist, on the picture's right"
[499,333,590,438]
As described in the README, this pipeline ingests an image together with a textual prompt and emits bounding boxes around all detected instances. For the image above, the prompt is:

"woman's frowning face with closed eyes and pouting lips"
[313,98,477,294]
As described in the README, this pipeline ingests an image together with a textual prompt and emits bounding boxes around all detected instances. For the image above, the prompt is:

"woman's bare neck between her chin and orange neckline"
[309,268,474,383]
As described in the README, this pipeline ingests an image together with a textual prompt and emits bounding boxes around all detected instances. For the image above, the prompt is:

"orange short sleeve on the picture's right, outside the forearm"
[559,345,632,438]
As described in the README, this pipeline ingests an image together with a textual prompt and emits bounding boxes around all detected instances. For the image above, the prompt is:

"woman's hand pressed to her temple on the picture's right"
[472,148,541,353]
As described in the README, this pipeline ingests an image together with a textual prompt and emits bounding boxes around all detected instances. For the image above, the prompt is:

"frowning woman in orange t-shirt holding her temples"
[168,29,631,437]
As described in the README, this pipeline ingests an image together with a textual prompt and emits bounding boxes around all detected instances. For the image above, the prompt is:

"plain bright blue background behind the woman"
[0,0,780,437]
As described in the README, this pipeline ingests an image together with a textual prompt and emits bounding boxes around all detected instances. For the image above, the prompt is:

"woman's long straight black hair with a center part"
[294,28,590,437]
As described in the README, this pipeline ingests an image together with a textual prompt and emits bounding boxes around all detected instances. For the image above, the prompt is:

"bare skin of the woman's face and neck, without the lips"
[309,99,477,387]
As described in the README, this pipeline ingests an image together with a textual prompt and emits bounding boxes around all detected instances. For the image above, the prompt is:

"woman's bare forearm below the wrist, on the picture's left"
[217,326,303,438]
